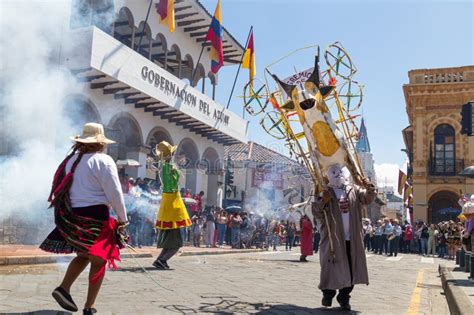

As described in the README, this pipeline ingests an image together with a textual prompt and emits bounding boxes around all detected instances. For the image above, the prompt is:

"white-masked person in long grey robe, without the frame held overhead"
[313,164,376,310]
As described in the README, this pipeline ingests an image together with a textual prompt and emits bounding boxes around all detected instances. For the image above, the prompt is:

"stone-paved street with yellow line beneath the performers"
[0,248,449,314]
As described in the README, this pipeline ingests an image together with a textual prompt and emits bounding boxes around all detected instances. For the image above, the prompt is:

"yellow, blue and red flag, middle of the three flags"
[206,0,224,73]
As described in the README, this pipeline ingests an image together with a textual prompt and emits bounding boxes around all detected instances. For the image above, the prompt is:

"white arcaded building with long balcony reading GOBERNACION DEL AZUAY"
[60,0,248,205]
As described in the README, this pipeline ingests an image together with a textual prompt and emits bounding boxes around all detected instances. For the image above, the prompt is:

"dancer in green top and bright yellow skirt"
[153,141,191,270]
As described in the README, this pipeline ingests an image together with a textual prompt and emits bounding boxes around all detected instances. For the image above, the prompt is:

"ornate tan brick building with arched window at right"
[402,66,474,222]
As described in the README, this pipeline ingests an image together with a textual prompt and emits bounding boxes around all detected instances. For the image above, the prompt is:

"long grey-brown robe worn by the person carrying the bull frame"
[312,185,376,290]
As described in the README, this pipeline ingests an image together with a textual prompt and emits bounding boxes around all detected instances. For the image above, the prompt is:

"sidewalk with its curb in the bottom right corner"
[439,265,474,315]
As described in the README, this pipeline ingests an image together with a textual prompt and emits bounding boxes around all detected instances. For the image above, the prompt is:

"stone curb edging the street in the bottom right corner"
[438,265,474,315]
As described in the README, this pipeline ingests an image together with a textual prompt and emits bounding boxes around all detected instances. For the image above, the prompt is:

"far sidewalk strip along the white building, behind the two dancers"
[0,245,262,266]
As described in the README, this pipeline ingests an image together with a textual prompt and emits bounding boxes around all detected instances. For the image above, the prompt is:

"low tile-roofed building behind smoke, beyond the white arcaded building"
[226,142,314,214]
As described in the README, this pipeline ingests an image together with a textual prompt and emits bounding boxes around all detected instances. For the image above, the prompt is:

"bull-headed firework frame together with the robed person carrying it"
[244,42,376,310]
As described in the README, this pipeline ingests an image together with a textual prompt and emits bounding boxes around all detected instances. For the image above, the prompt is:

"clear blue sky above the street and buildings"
[201,0,474,186]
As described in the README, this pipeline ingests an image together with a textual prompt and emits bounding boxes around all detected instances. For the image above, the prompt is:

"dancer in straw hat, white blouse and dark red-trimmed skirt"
[40,123,127,314]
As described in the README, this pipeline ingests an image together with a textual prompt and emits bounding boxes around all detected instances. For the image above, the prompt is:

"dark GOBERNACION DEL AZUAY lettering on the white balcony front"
[142,66,229,125]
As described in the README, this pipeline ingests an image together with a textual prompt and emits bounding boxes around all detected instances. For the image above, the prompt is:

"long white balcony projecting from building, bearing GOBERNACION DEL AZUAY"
[60,27,248,145]
